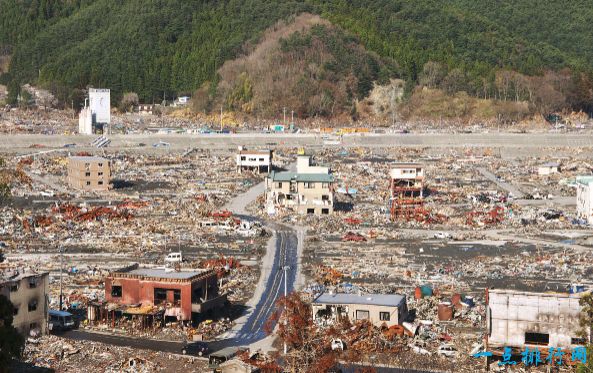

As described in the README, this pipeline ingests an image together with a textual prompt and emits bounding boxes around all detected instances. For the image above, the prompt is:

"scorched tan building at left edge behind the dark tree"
[0,272,49,336]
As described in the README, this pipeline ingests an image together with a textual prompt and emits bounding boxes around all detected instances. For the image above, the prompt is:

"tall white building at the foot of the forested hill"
[78,88,111,135]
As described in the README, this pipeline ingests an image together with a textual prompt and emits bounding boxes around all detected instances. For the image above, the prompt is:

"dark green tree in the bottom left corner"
[0,295,25,373]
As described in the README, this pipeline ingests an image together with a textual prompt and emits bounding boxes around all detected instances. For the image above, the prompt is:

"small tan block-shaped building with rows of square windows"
[68,157,111,191]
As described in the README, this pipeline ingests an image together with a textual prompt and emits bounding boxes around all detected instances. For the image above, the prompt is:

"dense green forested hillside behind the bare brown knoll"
[0,0,593,116]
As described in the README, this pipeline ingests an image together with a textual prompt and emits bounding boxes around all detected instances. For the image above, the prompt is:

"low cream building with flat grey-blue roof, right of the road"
[311,293,408,327]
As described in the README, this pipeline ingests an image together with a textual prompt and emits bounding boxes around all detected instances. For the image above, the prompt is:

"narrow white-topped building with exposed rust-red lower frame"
[389,163,424,220]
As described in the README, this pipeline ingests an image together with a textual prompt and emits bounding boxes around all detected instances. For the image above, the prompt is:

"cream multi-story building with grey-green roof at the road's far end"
[266,155,334,215]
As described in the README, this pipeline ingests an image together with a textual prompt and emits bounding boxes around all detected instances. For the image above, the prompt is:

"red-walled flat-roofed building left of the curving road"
[105,264,226,321]
